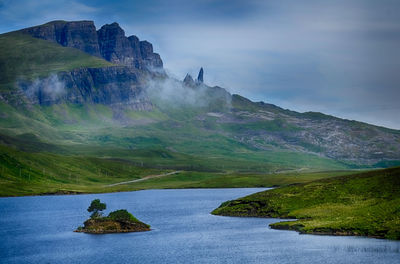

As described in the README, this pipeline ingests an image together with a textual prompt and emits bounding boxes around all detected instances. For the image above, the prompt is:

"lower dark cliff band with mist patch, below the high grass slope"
[18,66,152,110]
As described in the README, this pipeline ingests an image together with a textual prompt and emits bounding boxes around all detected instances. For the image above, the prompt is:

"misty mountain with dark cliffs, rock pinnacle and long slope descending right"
[0,21,400,171]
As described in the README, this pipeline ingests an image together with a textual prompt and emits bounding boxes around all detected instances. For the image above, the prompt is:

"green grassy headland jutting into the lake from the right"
[212,167,400,239]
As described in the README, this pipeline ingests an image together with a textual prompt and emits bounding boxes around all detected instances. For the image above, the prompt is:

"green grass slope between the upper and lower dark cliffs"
[0,32,112,85]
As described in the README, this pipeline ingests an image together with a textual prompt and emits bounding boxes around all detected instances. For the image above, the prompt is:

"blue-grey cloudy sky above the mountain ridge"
[0,0,400,129]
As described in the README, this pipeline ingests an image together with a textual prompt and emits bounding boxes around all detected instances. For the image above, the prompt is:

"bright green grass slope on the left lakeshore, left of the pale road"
[0,145,165,196]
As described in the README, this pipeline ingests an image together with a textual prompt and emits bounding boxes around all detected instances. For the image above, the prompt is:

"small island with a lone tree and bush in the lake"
[74,199,150,234]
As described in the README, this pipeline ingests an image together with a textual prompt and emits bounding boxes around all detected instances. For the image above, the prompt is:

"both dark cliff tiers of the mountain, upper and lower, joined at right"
[18,21,163,110]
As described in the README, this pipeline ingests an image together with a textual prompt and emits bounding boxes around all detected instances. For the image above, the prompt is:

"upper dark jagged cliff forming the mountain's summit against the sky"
[21,21,163,70]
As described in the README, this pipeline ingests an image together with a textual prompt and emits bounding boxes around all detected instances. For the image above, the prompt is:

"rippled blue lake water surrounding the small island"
[0,188,400,264]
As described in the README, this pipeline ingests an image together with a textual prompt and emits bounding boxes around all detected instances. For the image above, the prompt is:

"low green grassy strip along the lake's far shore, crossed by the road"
[0,141,350,196]
